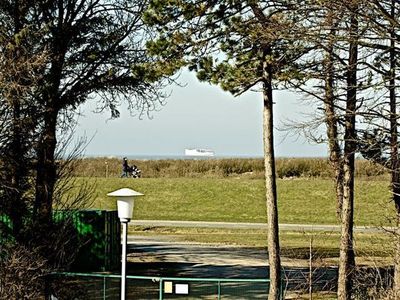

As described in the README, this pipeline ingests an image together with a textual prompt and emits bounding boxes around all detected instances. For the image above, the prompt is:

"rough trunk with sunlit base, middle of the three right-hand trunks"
[338,2,358,300]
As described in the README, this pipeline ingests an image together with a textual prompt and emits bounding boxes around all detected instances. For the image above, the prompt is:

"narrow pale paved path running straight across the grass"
[130,220,395,233]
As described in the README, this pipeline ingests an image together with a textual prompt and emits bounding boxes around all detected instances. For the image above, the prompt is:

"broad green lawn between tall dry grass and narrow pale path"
[70,177,393,225]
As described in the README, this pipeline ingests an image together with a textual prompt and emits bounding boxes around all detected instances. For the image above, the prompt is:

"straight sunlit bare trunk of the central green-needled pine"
[263,56,281,300]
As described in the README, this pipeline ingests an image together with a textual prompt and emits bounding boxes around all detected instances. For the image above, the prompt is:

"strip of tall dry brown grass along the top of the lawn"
[74,157,387,178]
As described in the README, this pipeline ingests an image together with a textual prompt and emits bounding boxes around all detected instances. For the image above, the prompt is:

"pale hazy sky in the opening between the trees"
[76,72,326,157]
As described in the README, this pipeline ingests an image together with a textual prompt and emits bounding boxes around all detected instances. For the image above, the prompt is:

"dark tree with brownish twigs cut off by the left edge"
[0,0,46,238]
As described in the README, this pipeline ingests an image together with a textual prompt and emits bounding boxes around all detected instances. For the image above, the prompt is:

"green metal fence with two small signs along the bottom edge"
[46,273,283,300]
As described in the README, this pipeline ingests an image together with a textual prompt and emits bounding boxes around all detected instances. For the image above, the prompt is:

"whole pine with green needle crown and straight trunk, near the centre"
[145,1,307,299]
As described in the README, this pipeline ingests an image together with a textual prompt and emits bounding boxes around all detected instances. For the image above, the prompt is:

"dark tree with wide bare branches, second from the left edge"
[18,0,166,224]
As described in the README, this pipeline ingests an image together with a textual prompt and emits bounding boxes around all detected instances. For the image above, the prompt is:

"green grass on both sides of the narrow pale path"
[63,177,394,261]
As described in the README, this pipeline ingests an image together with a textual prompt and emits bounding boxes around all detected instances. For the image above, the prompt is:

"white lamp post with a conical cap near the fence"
[107,188,143,300]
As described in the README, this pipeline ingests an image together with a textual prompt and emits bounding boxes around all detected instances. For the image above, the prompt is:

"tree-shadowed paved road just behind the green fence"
[127,235,337,292]
